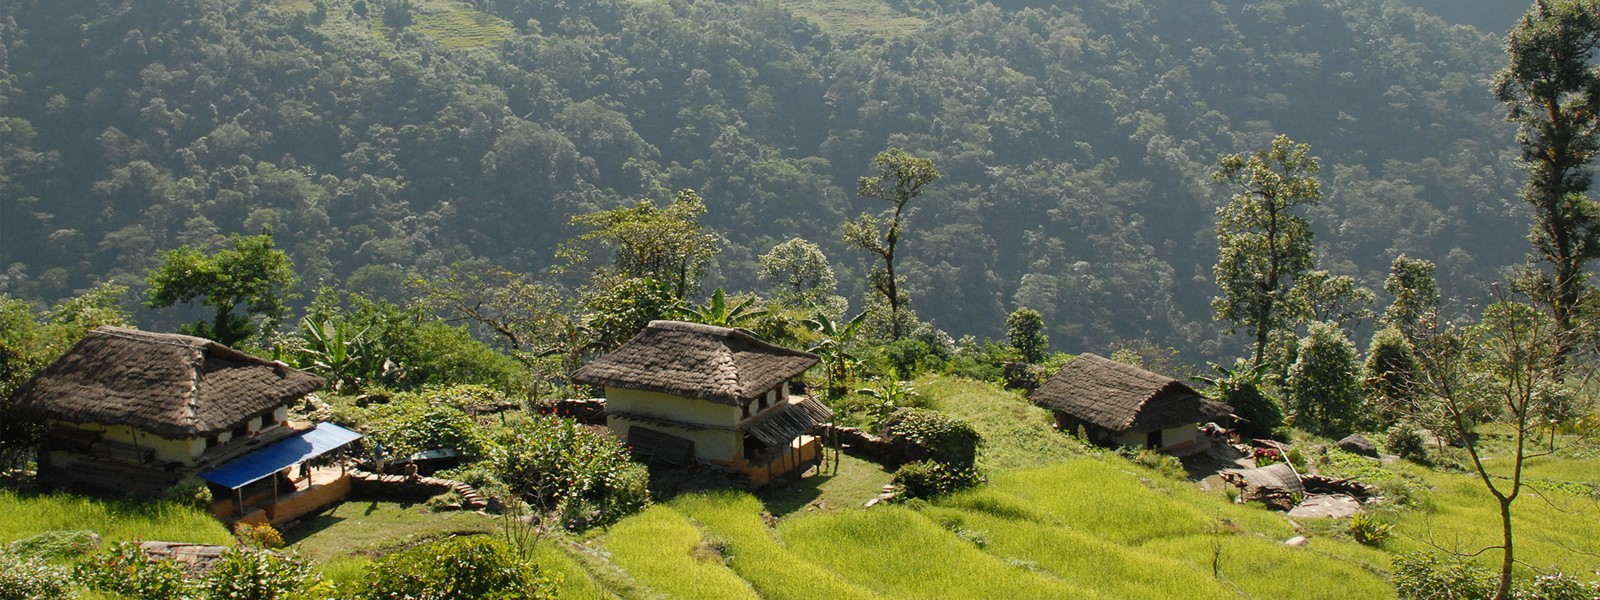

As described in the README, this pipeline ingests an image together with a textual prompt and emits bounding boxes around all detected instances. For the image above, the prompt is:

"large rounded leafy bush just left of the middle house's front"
[494,416,650,530]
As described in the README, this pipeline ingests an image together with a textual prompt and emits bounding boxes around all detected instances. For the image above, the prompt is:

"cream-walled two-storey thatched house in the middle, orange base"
[573,320,834,486]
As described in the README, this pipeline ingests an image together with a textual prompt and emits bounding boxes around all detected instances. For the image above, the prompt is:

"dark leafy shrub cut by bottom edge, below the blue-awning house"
[355,536,555,600]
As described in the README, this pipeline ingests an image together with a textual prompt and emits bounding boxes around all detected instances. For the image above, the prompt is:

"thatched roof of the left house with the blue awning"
[16,326,322,438]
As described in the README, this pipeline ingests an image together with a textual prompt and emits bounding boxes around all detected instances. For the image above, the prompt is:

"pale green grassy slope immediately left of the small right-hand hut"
[917,374,1088,470]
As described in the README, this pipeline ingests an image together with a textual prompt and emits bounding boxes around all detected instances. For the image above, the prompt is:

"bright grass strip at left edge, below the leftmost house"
[0,490,234,544]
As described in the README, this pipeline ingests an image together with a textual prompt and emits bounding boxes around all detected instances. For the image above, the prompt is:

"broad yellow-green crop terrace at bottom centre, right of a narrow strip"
[778,506,1101,598]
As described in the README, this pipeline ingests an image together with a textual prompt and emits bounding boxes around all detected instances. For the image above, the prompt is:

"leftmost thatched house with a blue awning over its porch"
[16,326,360,517]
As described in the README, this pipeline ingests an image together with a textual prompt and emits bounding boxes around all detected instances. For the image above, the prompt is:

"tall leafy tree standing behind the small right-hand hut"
[1211,136,1322,365]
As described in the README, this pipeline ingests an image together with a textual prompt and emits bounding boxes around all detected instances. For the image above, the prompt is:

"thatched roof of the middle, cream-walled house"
[573,320,818,405]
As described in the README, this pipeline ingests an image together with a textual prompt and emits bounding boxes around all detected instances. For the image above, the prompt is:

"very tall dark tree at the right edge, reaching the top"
[1493,0,1600,355]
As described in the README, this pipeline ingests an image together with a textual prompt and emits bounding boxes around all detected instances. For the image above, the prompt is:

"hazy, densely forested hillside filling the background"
[0,0,1526,357]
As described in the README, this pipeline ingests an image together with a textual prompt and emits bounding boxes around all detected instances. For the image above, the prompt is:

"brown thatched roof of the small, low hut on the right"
[1029,354,1234,432]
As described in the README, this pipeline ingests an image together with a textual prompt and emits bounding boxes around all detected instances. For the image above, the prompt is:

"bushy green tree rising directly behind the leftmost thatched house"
[146,232,298,346]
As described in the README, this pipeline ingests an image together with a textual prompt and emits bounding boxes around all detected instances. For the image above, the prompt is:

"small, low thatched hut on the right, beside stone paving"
[1029,354,1234,454]
